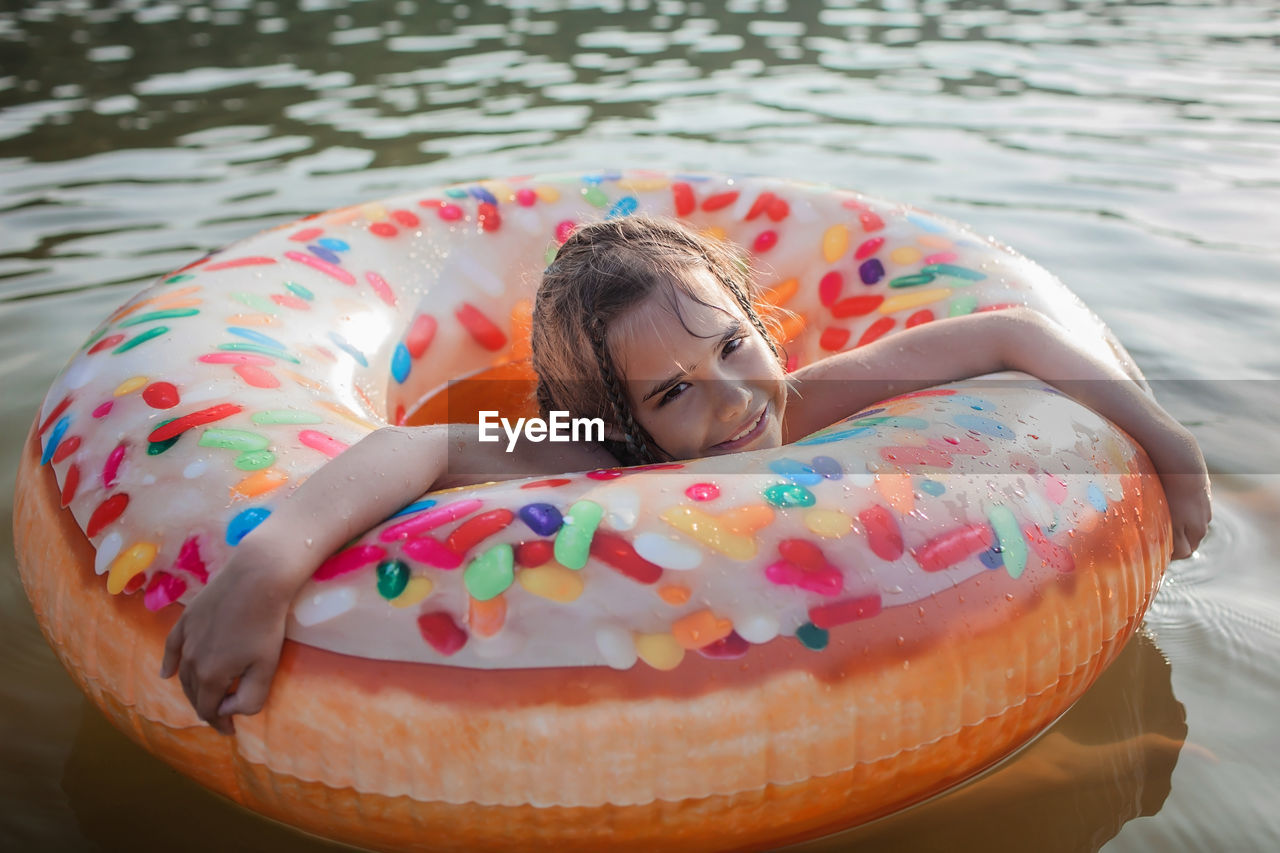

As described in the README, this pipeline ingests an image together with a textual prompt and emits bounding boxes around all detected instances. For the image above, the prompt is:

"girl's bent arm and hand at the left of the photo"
[160,424,616,734]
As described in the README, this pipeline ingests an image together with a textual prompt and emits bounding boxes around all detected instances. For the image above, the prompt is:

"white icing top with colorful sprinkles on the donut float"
[32,172,1152,670]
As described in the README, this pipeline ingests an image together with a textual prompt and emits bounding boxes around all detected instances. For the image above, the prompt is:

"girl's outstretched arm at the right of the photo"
[783,309,1211,560]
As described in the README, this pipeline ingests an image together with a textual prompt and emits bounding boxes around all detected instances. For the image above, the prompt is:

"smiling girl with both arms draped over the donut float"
[161,212,1210,734]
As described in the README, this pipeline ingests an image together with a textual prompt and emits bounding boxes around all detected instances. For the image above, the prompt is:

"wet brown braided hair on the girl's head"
[530,216,781,465]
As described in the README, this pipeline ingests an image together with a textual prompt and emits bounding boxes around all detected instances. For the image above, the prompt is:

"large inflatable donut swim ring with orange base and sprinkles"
[17,172,1171,850]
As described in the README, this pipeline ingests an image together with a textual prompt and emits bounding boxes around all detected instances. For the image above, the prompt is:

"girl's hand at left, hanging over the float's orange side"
[160,538,296,734]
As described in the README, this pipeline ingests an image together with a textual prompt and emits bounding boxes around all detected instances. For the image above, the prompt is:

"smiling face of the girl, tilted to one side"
[609,270,786,459]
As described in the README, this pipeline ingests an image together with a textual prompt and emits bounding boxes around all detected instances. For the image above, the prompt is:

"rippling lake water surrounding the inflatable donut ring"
[0,0,1280,852]
